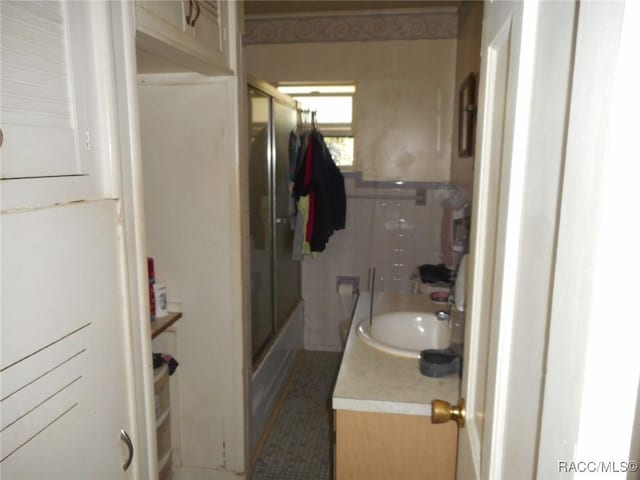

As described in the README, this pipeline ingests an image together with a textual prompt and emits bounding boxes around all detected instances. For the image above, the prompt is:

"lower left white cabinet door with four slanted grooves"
[0,200,138,480]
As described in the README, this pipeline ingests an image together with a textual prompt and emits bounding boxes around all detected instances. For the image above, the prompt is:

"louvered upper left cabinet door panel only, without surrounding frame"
[0,2,91,179]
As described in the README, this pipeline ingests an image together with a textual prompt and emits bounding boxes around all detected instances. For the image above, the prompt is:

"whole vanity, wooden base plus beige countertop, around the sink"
[333,292,460,480]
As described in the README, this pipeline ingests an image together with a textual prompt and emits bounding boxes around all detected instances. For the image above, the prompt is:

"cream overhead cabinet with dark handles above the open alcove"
[136,0,233,75]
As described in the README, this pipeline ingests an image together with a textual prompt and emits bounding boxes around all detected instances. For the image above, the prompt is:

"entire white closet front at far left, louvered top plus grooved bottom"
[0,0,136,480]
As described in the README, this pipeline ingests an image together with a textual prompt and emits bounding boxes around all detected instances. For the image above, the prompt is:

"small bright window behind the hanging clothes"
[278,84,356,169]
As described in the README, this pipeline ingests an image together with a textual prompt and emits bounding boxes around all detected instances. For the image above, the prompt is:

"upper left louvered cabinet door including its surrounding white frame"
[0,1,117,211]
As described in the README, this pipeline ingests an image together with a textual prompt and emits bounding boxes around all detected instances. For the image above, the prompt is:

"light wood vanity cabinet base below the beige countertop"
[335,410,458,480]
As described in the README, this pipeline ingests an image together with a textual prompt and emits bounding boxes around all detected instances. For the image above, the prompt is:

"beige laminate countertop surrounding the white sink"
[333,292,460,416]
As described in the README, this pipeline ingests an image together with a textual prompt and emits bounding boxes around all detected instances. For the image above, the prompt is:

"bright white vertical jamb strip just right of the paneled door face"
[492,1,577,478]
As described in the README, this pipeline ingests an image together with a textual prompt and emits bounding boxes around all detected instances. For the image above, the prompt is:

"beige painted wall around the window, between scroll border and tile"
[245,39,456,182]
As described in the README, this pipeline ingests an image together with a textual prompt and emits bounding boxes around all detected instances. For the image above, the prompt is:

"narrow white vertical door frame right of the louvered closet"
[110,2,158,479]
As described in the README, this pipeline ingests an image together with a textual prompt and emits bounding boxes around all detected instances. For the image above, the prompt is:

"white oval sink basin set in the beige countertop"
[356,312,451,358]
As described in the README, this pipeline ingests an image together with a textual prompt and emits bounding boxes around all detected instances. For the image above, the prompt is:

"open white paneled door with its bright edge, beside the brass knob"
[450,0,592,479]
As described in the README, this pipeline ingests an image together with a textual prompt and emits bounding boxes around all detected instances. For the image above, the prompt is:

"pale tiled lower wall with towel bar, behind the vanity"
[302,178,453,351]
